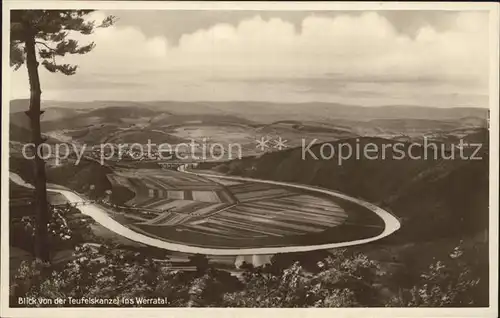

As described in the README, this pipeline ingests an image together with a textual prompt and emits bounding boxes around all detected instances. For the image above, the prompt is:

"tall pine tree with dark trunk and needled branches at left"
[10,10,115,261]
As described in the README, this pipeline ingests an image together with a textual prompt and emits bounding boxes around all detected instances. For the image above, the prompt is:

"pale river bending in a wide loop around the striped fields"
[10,166,400,256]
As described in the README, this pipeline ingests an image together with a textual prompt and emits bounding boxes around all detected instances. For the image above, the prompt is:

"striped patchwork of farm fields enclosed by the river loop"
[103,169,384,248]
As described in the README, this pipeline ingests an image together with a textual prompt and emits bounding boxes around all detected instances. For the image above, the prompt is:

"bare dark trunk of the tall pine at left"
[25,36,50,261]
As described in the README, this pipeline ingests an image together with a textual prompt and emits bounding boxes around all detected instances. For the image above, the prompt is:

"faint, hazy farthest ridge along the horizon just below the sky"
[10,99,488,122]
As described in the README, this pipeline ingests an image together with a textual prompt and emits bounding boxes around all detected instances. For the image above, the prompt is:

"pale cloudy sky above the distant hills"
[11,10,489,107]
